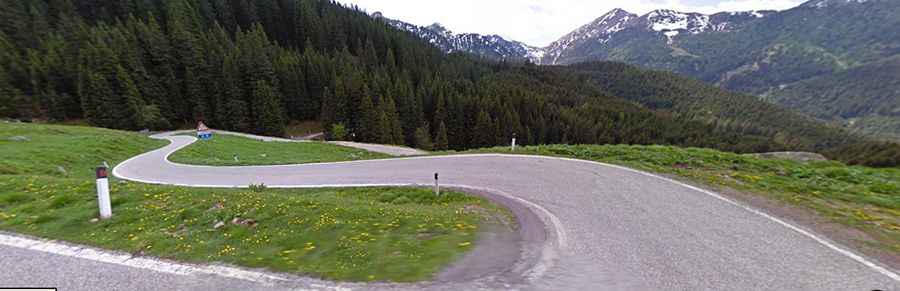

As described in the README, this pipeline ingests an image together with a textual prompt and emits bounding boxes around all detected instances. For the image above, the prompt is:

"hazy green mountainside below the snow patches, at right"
[548,0,900,141]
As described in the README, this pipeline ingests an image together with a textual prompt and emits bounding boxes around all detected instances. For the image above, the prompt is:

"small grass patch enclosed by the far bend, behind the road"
[169,134,388,166]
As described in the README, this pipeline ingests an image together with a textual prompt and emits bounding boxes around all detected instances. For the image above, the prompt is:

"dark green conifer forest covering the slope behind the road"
[0,0,900,166]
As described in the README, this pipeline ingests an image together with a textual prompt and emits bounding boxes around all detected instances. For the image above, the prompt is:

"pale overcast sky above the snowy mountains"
[339,0,806,47]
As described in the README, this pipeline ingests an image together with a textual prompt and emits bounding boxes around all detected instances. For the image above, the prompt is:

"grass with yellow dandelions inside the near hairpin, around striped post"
[0,123,508,281]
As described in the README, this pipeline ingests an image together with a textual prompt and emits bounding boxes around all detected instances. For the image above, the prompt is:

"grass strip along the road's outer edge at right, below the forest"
[464,145,900,254]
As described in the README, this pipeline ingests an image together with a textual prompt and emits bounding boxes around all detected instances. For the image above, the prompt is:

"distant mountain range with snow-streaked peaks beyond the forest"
[380,0,900,139]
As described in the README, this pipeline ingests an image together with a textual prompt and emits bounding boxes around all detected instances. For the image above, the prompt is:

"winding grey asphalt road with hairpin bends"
[0,136,900,290]
